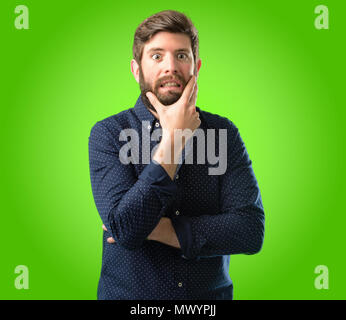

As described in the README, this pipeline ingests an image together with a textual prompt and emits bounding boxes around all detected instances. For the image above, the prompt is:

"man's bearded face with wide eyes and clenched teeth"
[134,32,200,108]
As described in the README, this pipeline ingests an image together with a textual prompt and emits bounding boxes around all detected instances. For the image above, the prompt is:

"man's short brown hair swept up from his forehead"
[132,10,199,65]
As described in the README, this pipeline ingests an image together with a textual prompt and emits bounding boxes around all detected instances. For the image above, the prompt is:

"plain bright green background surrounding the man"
[0,0,346,299]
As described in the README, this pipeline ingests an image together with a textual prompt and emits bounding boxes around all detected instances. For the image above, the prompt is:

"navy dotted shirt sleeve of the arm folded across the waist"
[172,122,264,259]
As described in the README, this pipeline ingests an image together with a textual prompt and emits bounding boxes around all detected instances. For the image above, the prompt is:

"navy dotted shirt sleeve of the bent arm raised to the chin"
[89,122,177,250]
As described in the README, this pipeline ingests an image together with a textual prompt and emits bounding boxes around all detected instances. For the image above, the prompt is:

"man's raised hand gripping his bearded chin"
[146,75,201,140]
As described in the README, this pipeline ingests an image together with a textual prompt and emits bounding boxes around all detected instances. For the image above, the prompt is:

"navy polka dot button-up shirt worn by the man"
[89,96,264,300]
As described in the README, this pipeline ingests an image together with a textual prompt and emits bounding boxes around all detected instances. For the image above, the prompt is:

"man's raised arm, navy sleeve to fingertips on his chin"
[89,76,200,249]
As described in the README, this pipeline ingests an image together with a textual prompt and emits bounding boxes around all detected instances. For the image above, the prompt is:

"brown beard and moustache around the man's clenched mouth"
[139,66,196,112]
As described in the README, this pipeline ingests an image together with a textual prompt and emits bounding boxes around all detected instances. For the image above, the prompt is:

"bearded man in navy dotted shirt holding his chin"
[89,10,264,300]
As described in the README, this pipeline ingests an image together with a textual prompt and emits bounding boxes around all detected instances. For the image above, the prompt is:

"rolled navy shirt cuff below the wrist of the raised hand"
[138,160,178,195]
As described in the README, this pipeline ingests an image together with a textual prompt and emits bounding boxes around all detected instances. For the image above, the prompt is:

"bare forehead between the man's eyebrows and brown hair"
[143,32,192,53]
